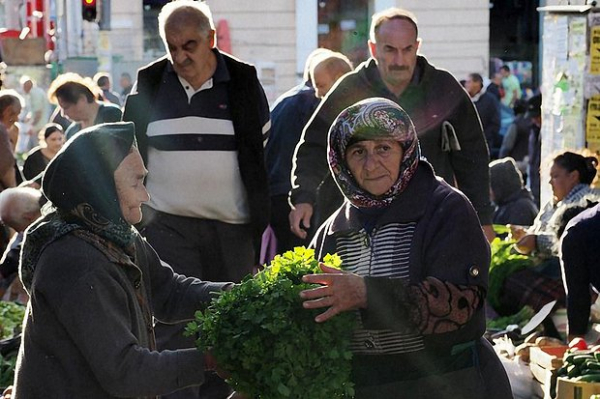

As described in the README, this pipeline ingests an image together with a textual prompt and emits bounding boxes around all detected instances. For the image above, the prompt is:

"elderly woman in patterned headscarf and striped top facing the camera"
[300,98,512,399]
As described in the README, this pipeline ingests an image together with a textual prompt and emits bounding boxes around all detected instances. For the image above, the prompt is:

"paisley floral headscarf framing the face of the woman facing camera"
[328,97,421,208]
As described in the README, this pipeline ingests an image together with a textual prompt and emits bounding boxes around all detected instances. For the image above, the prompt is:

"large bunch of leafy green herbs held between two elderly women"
[186,247,356,399]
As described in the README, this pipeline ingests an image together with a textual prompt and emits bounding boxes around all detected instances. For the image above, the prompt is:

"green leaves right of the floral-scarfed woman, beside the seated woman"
[487,236,534,309]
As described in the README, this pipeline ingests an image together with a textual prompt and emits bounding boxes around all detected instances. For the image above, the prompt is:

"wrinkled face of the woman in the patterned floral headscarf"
[346,140,404,195]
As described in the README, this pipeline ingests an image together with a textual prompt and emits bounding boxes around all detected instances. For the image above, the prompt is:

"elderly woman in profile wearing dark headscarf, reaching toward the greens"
[14,123,230,399]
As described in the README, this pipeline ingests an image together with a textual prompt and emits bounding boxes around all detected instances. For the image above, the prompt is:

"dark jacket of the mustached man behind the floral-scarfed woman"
[291,56,493,225]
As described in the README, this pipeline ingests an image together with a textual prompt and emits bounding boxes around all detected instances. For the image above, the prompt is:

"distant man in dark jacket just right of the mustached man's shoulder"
[465,73,501,159]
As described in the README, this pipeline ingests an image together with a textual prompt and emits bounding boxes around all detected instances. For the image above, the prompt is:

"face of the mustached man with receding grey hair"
[369,19,419,94]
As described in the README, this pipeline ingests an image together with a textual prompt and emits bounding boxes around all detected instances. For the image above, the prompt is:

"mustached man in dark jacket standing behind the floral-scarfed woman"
[290,8,494,239]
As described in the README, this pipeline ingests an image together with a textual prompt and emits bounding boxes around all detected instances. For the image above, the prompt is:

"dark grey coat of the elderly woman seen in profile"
[15,230,230,399]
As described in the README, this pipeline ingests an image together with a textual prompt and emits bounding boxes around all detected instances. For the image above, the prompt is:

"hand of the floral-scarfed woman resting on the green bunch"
[300,263,367,323]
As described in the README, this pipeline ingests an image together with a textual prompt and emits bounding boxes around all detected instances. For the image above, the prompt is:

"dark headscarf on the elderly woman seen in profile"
[20,122,136,288]
